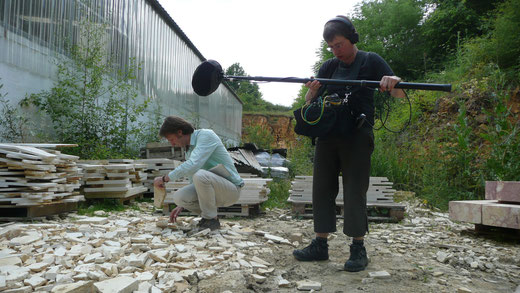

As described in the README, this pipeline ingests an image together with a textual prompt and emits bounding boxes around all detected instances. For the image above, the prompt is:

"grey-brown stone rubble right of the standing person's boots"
[367,198,520,283]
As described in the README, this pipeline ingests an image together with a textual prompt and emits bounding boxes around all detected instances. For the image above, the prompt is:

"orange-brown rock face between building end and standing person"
[242,114,295,148]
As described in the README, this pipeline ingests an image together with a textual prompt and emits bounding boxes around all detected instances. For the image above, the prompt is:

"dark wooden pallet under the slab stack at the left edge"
[0,201,78,222]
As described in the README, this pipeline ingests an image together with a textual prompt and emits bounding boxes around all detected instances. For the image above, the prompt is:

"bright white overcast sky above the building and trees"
[159,0,360,106]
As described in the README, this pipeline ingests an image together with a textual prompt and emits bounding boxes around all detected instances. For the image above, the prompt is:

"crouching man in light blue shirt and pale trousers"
[154,116,244,230]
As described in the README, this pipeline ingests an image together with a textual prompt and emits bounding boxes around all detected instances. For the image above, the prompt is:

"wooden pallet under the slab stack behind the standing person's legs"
[292,201,405,223]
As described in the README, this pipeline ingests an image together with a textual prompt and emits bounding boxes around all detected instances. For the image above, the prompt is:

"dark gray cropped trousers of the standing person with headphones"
[312,128,374,237]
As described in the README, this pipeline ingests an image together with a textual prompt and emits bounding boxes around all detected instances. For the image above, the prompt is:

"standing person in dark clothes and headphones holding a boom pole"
[293,16,405,272]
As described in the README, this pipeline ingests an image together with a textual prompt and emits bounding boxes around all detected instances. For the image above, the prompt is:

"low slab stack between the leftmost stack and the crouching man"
[81,162,148,199]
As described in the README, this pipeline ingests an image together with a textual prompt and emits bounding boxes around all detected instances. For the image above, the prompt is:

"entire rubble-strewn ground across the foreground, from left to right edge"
[0,197,520,293]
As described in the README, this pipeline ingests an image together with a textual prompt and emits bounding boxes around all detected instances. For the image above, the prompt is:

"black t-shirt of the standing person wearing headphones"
[317,50,394,125]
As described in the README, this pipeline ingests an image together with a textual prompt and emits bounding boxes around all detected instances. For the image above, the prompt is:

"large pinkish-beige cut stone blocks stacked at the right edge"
[449,181,520,229]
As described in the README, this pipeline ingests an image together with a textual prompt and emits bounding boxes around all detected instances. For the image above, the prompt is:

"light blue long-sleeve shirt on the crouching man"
[168,129,244,186]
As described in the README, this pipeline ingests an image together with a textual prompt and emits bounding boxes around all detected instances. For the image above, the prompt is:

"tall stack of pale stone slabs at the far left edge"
[0,144,84,207]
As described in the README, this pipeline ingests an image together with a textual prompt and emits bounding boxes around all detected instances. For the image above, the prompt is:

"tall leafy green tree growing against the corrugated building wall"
[23,20,148,158]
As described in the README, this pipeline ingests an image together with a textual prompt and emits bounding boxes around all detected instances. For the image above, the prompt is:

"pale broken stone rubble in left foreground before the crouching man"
[0,203,293,293]
